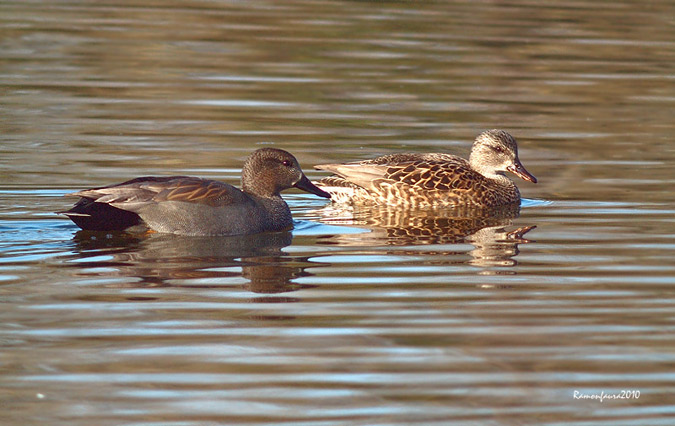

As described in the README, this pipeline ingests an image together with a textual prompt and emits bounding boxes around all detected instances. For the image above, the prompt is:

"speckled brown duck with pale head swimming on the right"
[315,130,537,208]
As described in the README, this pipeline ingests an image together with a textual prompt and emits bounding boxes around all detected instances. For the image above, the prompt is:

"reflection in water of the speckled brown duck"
[319,205,536,274]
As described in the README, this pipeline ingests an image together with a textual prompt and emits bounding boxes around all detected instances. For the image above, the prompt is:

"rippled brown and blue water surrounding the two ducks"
[0,0,675,425]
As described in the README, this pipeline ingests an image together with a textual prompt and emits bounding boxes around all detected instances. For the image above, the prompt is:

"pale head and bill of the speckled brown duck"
[469,129,537,183]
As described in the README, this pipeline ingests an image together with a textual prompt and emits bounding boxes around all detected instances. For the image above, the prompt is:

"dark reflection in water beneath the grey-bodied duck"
[67,231,317,294]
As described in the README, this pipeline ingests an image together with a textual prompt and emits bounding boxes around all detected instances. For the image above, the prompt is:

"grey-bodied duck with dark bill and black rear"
[62,148,330,235]
